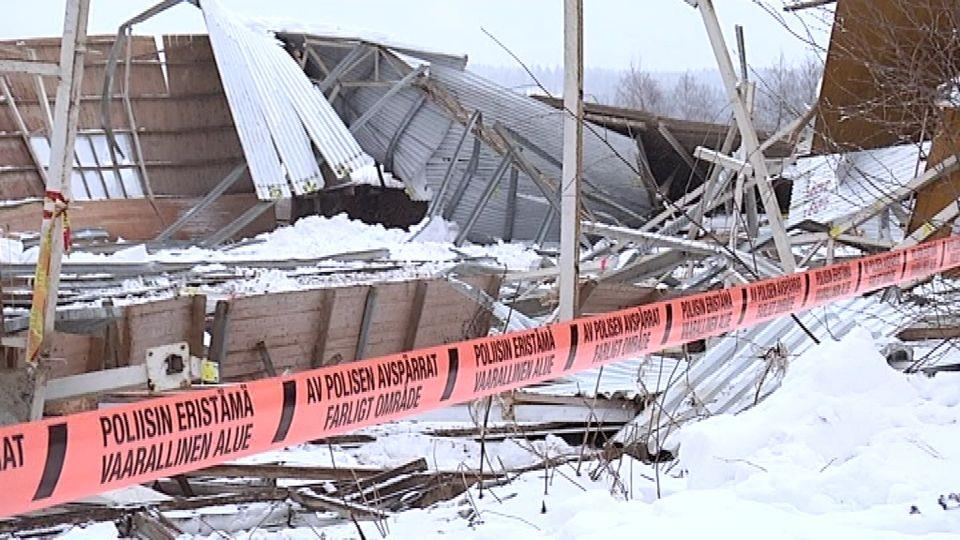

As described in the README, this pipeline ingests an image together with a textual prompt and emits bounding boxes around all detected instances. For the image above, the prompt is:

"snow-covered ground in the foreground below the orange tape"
[54,330,960,540]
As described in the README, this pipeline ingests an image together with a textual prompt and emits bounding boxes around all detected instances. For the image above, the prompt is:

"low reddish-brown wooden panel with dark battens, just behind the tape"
[211,276,500,380]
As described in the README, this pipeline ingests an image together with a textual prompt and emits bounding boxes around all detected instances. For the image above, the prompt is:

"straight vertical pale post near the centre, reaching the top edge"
[559,0,583,321]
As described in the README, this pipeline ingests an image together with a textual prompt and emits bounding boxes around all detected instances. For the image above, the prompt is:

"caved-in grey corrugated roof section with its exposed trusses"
[277,33,651,241]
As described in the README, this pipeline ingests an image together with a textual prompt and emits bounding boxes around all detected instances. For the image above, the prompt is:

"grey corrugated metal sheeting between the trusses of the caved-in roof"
[281,34,650,241]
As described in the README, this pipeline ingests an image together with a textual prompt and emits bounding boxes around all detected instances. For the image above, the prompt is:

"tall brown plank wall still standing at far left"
[0,35,253,200]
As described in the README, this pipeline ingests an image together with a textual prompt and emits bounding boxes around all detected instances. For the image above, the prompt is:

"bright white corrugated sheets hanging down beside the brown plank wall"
[201,0,376,200]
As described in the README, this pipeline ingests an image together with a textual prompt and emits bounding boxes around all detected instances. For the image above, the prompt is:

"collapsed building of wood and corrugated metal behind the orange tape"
[0,0,960,532]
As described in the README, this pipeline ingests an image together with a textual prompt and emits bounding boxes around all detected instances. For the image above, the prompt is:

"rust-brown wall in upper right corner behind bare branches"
[813,0,960,154]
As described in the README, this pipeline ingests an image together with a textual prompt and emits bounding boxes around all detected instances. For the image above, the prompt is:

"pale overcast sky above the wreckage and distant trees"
[0,0,829,71]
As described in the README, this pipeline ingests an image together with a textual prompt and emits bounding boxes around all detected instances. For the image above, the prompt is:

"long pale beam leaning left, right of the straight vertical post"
[688,0,796,273]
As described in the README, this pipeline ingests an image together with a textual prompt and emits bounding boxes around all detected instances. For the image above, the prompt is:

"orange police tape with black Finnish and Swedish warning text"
[0,237,960,516]
